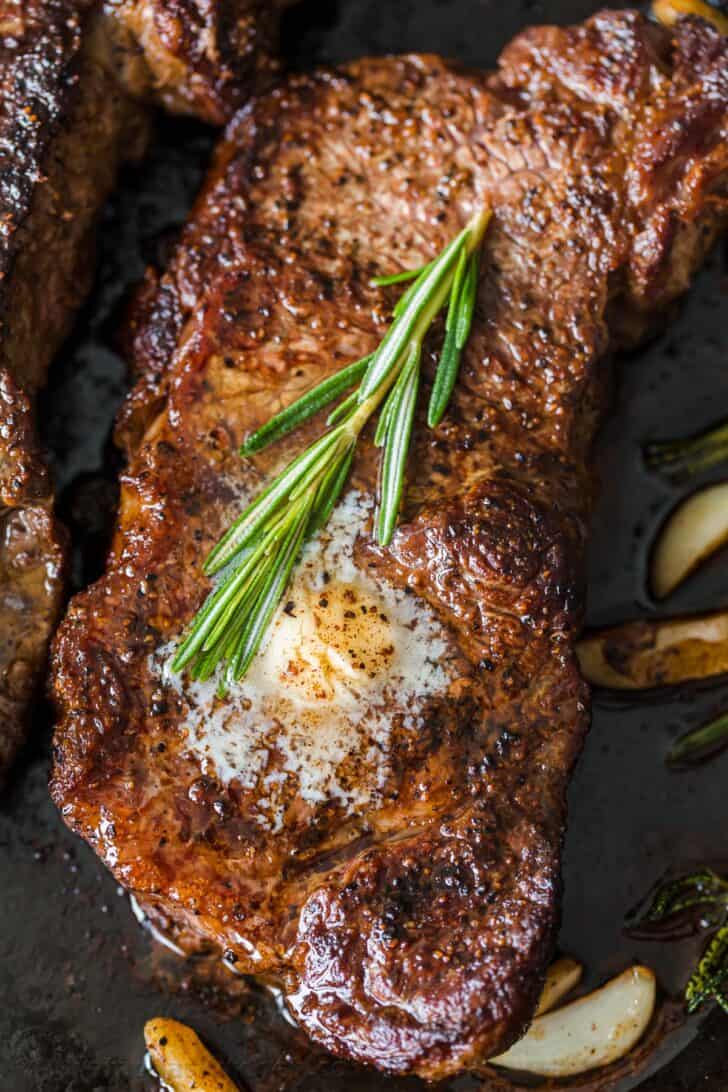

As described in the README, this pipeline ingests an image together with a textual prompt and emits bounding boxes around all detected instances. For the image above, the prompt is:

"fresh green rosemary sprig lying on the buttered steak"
[172,210,491,692]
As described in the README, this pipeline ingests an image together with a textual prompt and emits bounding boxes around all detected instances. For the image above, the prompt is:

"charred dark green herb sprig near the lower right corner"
[630,868,728,1012]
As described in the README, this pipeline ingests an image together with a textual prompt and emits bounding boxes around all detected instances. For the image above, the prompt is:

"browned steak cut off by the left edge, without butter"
[0,0,290,773]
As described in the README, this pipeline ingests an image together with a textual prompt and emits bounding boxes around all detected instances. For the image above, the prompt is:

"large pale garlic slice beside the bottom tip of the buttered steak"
[490,966,656,1077]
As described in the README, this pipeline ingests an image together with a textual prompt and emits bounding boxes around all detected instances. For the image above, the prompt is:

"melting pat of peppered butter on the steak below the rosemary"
[153,492,451,830]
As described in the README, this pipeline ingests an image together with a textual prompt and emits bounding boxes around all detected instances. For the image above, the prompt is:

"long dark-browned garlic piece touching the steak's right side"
[576,612,728,690]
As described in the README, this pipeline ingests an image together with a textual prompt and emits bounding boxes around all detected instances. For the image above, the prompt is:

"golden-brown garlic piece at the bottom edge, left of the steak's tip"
[144,1017,239,1092]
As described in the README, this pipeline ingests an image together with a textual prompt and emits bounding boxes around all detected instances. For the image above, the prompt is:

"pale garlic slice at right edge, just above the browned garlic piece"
[651,482,728,600]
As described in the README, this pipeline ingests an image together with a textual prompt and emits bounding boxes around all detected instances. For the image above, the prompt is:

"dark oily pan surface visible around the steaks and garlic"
[0,0,728,1092]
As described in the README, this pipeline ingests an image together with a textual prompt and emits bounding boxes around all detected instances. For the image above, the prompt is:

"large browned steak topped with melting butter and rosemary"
[51,11,728,1079]
